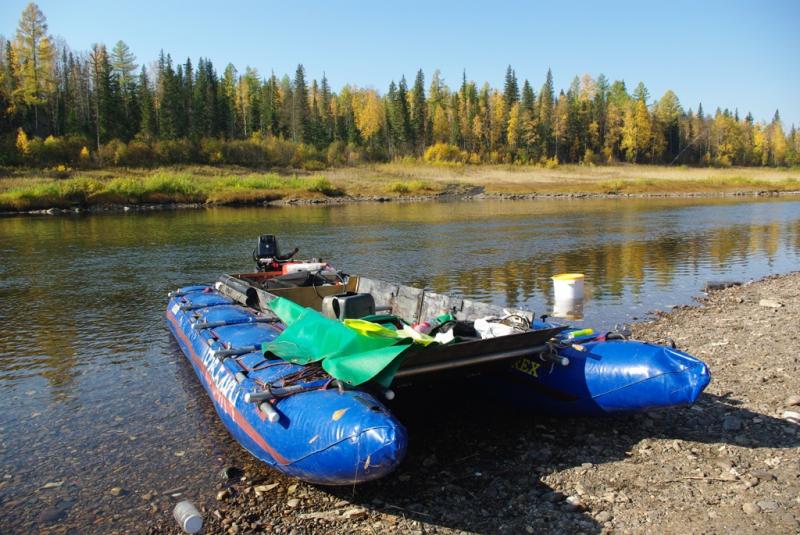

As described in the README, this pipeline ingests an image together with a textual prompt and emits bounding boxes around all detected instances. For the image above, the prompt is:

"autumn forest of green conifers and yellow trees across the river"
[0,3,800,170]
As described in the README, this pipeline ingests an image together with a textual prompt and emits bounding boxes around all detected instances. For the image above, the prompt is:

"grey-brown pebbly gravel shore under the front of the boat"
[141,273,800,534]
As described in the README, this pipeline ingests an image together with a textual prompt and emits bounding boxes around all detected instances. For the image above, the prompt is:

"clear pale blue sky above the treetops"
[0,0,800,127]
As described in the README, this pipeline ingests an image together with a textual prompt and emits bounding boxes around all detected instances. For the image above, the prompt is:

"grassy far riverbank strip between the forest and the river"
[0,163,800,213]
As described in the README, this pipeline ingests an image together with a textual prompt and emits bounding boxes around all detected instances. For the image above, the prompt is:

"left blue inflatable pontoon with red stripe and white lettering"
[167,286,407,485]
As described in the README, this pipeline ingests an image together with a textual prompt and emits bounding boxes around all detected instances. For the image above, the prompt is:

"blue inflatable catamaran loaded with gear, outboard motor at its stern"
[166,236,710,485]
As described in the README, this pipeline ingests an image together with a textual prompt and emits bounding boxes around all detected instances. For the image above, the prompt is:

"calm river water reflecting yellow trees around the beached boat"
[0,198,800,533]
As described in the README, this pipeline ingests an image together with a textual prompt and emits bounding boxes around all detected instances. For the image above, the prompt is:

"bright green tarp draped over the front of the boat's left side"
[263,297,412,387]
